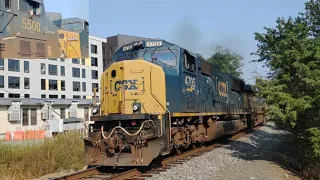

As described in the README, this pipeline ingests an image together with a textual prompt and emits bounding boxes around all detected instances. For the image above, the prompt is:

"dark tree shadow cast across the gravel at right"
[225,122,304,179]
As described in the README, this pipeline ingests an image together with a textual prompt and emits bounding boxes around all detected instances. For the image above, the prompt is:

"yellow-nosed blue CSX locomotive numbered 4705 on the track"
[84,39,266,167]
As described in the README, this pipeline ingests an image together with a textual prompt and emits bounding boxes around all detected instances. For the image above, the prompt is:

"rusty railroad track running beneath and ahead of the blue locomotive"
[56,126,261,180]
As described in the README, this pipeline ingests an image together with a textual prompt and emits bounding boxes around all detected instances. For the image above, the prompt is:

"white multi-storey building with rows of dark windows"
[0,36,106,138]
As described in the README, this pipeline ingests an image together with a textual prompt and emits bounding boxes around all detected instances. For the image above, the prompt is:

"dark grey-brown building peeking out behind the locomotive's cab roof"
[103,34,155,70]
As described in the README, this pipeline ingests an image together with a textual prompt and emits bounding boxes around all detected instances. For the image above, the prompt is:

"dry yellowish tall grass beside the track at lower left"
[0,132,85,179]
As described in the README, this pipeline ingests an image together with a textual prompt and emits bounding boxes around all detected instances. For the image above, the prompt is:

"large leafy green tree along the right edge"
[254,0,320,178]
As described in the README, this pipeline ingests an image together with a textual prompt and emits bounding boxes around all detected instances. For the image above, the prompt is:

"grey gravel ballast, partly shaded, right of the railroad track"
[148,122,301,180]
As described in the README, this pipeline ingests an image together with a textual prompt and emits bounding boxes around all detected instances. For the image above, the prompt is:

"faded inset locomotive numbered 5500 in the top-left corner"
[0,0,89,59]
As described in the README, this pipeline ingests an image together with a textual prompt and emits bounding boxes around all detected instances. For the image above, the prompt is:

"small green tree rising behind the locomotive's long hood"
[207,46,243,78]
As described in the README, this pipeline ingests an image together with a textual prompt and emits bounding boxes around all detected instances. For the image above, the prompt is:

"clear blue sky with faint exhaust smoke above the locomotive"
[45,0,306,83]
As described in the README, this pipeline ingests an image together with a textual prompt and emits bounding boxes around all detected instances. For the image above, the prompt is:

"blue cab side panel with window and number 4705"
[182,50,199,112]
